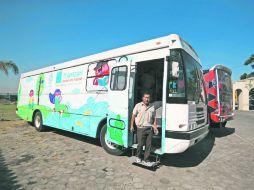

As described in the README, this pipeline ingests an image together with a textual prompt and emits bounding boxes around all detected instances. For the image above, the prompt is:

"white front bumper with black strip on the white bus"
[165,124,209,153]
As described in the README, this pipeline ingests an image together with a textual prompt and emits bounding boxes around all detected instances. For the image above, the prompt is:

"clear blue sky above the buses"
[0,0,254,92]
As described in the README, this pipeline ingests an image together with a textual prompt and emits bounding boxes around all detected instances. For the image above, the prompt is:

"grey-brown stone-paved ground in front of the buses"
[0,111,254,190]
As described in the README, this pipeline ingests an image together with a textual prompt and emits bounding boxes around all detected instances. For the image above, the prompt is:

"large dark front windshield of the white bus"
[167,50,206,103]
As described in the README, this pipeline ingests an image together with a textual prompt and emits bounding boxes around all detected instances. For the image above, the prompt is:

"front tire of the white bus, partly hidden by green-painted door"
[100,124,124,156]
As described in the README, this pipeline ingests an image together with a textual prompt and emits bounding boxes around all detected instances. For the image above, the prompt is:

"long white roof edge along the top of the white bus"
[21,34,200,78]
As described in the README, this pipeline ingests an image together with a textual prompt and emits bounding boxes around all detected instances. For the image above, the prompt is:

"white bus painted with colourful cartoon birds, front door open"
[17,34,208,155]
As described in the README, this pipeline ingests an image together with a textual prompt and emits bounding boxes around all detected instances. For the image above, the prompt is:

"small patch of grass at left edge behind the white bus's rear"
[0,104,19,121]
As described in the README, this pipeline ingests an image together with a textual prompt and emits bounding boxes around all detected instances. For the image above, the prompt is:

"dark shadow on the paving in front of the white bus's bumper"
[161,128,235,167]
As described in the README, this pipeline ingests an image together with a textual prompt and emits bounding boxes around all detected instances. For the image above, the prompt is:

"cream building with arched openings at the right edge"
[233,77,254,110]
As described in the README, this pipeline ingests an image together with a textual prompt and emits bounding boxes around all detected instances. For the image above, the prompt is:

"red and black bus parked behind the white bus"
[203,65,234,127]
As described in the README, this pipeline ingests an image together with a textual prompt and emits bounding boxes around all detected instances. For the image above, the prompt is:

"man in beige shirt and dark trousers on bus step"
[130,92,158,165]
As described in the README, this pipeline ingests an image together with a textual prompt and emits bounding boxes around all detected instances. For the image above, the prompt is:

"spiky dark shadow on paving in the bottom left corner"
[0,150,21,190]
